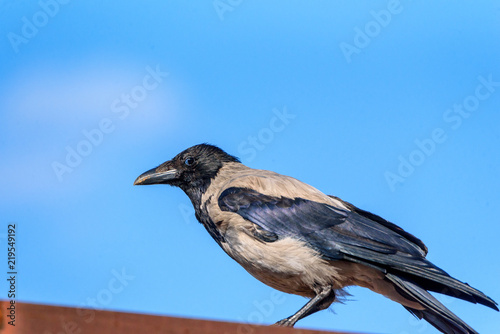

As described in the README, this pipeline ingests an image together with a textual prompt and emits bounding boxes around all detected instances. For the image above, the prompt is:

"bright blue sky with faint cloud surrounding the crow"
[0,0,500,334]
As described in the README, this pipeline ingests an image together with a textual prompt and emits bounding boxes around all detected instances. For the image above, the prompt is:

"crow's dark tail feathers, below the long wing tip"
[386,273,478,334]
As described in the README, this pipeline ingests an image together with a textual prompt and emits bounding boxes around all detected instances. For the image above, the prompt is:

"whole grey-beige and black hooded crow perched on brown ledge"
[134,144,498,334]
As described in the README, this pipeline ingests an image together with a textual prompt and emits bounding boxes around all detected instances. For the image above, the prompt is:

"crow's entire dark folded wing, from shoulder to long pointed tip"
[218,187,494,307]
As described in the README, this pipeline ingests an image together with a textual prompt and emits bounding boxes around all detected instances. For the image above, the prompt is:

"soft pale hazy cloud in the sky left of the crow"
[0,59,182,200]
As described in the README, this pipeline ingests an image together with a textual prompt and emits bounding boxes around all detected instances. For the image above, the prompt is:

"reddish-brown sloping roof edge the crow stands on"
[0,301,368,334]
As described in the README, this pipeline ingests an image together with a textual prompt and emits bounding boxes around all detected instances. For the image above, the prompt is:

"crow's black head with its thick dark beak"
[134,144,240,192]
